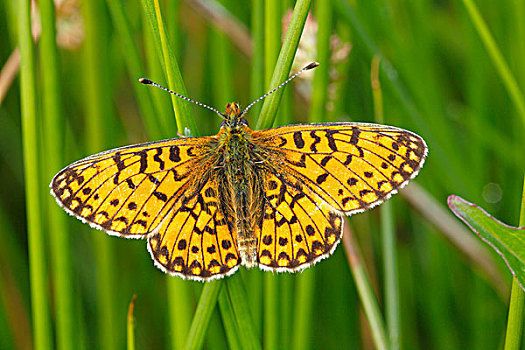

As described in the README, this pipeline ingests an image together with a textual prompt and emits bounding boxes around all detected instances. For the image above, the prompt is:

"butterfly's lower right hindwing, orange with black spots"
[256,174,342,272]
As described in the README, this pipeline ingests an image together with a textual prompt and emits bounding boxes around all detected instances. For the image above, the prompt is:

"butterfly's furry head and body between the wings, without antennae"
[218,103,262,268]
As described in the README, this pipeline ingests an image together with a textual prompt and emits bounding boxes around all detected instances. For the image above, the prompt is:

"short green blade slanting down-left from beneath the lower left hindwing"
[186,281,223,349]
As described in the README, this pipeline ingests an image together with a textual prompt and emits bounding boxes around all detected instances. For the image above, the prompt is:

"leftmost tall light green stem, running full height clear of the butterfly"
[18,0,53,350]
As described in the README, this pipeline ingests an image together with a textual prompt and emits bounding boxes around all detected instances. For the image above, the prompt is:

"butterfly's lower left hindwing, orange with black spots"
[148,173,240,280]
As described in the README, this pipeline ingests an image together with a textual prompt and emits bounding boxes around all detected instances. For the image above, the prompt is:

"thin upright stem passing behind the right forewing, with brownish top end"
[370,56,400,350]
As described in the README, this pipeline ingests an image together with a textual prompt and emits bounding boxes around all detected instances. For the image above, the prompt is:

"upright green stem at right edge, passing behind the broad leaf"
[505,177,525,350]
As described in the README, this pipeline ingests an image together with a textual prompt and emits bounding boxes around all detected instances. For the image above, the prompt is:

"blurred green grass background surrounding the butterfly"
[0,0,525,349]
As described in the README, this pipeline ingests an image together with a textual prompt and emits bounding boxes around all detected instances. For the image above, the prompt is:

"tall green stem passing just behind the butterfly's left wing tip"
[39,0,77,350]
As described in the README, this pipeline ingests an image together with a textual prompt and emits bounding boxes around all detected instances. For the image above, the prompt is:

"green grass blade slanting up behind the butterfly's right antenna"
[256,0,311,129]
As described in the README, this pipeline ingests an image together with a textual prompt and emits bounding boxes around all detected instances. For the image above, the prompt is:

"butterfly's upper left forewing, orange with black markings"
[50,137,214,238]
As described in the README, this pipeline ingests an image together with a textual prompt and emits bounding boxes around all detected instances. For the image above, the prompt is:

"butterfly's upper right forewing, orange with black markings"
[253,123,428,215]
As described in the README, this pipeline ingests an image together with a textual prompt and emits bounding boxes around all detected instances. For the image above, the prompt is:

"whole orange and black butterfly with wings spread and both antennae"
[50,63,428,281]
